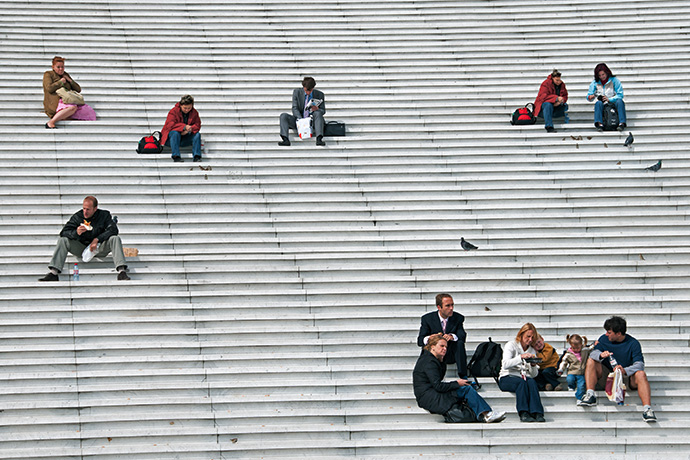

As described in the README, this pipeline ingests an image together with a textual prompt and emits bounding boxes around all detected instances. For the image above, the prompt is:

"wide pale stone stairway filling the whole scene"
[0,0,690,460]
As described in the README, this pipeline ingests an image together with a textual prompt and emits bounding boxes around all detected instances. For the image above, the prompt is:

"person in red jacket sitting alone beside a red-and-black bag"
[161,95,201,162]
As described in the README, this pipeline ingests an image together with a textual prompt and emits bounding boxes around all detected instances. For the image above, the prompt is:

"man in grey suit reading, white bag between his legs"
[278,77,326,146]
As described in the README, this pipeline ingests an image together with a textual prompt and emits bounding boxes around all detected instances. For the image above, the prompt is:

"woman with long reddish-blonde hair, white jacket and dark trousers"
[498,323,545,422]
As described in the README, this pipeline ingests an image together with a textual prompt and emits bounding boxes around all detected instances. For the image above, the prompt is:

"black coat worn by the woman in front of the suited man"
[412,350,460,415]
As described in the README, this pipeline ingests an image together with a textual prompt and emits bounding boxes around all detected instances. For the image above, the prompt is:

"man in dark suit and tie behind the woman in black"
[417,294,467,379]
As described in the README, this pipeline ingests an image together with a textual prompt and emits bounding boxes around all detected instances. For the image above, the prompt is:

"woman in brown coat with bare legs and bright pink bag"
[43,56,96,129]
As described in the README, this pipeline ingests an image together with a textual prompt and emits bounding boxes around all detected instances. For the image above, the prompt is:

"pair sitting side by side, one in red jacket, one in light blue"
[534,62,627,133]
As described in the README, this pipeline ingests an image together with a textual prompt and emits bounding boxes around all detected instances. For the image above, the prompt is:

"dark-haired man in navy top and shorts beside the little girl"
[580,316,656,422]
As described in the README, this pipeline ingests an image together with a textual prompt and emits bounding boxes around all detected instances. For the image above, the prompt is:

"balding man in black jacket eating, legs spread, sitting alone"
[38,196,130,281]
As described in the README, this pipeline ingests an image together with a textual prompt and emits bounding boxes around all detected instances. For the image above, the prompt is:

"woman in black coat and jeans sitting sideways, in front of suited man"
[412,334,505,423]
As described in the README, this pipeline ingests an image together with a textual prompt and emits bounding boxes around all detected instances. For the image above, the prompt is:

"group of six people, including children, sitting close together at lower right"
[412,293,656,423]
